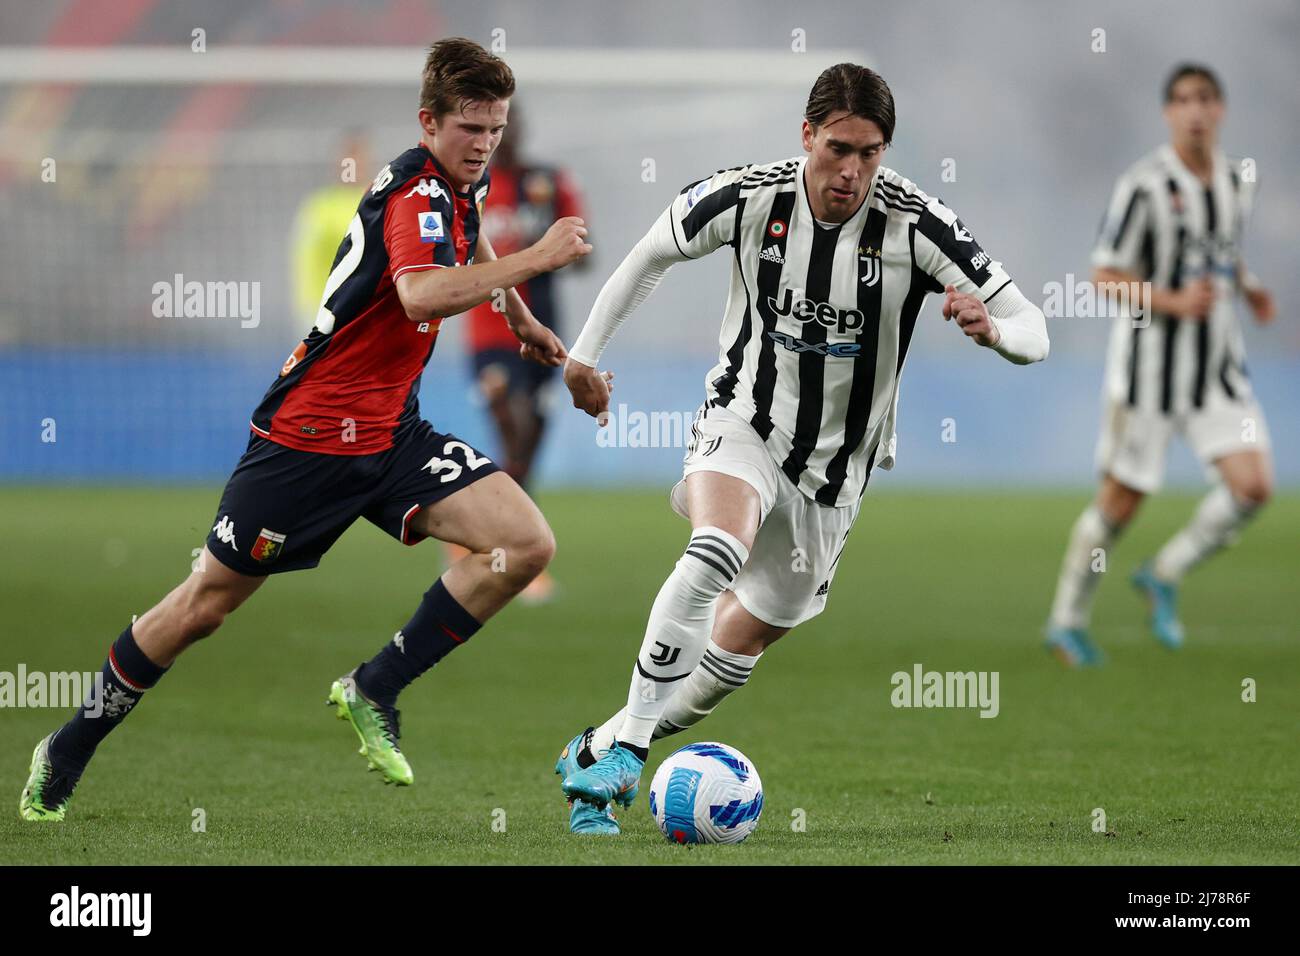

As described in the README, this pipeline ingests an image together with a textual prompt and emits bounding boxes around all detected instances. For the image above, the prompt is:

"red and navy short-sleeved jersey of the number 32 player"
[251,144,489,455]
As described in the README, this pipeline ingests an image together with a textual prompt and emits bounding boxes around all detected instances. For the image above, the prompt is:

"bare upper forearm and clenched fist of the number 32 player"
[397,216,592,321]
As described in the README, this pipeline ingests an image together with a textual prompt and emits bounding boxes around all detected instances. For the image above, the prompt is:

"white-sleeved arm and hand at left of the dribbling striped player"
[564,211,689,423]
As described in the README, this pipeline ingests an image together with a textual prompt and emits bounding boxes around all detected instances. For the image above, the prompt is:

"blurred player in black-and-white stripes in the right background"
[1047,64,1274,667]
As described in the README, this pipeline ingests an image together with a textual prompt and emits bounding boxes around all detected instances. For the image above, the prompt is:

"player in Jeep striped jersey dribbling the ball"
[556,64,1048,832]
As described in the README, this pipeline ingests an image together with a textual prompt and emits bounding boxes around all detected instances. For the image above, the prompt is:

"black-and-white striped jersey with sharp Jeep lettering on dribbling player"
[668,156,1011,506]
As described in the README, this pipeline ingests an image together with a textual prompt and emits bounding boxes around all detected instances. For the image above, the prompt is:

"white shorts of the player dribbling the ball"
[670,405,861,627]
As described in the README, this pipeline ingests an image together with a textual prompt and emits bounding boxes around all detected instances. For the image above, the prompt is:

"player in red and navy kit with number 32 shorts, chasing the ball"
[20,33,592,821]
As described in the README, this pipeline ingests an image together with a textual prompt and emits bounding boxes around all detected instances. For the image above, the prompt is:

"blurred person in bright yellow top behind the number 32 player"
[290,133,374,323]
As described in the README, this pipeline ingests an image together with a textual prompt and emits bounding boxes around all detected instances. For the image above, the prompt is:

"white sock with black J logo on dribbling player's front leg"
[615,527,749,747]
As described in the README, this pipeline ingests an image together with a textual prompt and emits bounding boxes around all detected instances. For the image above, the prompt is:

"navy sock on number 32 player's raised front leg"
[356,578,481,708]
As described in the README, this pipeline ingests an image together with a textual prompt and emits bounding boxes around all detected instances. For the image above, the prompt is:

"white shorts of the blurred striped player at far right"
[1097,399,1271,494]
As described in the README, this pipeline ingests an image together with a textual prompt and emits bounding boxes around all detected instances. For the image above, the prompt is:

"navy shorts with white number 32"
[208,421,499,576]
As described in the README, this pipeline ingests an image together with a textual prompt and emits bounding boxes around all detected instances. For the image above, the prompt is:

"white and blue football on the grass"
[650,743,763,843]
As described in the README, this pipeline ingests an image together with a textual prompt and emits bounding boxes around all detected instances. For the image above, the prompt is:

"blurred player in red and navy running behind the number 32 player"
[451,103,586,602]
